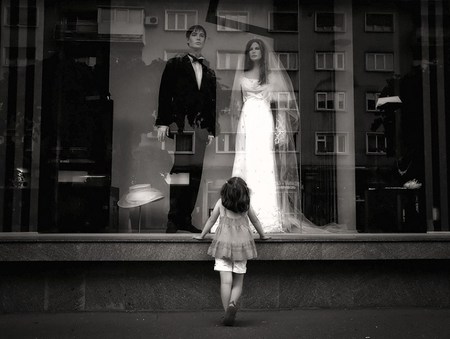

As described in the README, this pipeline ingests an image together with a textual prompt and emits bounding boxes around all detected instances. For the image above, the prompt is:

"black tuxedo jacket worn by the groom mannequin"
[155,55,216,135]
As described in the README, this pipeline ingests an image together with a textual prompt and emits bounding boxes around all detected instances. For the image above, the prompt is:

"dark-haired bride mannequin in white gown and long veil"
[230,39,322,233]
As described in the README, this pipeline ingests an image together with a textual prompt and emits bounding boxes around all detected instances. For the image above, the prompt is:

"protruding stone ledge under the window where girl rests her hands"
[0,232,450,262]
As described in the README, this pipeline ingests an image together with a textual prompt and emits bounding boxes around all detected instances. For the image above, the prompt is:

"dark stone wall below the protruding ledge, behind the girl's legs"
[0,260,450,313]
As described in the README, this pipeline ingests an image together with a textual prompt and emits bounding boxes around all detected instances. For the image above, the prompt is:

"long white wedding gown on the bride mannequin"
[232,76,283,233]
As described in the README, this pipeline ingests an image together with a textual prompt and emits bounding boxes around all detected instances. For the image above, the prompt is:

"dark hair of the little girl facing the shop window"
[220,177,250,213]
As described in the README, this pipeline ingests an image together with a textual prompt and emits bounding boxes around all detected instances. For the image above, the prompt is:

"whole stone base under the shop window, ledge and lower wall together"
[0,234,450,313]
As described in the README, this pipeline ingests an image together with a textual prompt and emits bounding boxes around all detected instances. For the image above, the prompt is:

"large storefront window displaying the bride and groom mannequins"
[0,0,450,236]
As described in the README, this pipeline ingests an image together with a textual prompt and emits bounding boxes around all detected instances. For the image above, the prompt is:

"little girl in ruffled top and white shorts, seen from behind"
[194,177,269,326]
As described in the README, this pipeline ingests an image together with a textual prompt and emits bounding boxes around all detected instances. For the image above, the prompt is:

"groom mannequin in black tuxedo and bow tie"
[155,25,216,233]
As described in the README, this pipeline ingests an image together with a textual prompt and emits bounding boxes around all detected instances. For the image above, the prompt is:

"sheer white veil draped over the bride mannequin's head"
[229,38,312,232]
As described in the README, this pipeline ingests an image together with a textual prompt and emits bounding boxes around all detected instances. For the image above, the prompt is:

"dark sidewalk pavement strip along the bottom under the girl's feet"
[0,308,450,339]
